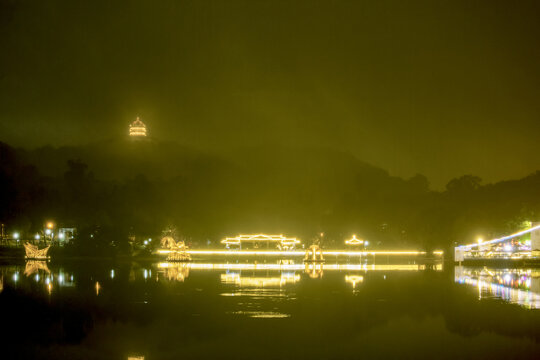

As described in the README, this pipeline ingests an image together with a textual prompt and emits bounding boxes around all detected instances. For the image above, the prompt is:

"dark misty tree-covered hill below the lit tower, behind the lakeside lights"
[0,141,540,255]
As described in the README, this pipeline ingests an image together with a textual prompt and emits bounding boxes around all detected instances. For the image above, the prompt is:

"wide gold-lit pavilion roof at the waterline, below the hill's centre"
[221,234,300,250]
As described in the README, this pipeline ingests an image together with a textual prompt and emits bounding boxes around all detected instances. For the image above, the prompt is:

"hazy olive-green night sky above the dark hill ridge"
[0,0,540,187]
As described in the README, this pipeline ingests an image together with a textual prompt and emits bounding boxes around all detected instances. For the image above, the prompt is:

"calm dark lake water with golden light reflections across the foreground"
[0,259,540,360]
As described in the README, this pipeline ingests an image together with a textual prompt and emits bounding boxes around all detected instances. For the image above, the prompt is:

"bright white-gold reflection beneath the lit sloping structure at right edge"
[454,266,540,309]
